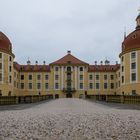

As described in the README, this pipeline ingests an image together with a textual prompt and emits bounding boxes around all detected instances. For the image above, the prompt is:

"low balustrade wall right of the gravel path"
[86,95,140,104]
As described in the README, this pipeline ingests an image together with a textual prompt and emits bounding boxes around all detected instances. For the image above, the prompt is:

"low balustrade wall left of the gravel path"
[0,95,53,105]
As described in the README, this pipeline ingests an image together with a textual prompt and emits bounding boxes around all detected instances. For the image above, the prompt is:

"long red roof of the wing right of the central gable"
[88,64,120,72]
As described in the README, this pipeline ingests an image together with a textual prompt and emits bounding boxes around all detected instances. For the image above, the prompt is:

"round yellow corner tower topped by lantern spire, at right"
[120,10,140,95]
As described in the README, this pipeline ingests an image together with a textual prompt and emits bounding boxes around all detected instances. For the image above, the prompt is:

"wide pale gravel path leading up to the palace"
[0,99,140,140]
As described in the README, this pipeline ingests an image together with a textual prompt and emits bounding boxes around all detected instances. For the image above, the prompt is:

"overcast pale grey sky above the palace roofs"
[0,0,140,64]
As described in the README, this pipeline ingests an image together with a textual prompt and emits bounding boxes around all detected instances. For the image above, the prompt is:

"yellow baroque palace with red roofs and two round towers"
[0,14,140,98]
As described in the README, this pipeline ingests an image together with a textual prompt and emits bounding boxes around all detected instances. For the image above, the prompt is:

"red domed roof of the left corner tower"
[0,31,12,53]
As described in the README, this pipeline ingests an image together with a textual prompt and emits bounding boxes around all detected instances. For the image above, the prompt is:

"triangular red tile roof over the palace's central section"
[50,54,89,65]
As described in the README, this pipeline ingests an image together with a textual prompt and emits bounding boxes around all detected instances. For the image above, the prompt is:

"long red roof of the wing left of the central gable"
[14,62,50,72]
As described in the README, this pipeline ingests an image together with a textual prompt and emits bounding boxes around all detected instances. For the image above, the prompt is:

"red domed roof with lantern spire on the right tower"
[120,11,140,55]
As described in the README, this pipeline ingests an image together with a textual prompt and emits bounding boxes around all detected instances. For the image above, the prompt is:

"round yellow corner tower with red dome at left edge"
[0,32,15,96]
